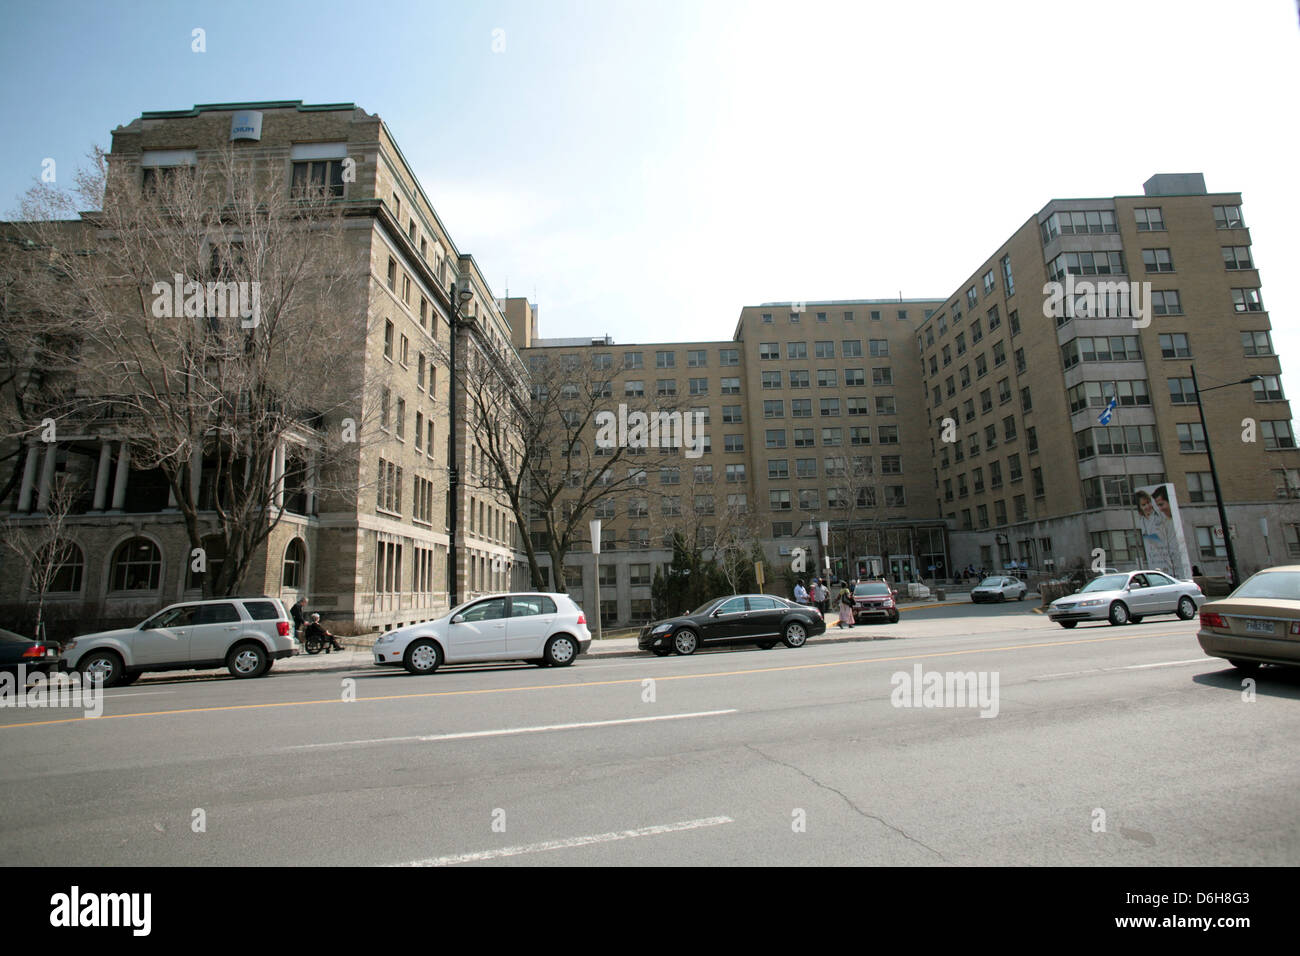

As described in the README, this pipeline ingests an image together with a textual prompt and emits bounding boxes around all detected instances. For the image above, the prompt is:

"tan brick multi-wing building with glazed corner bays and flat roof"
[515,174,1300,622]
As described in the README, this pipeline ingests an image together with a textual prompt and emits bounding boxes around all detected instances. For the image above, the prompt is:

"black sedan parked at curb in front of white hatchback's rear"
[637,594,826,657]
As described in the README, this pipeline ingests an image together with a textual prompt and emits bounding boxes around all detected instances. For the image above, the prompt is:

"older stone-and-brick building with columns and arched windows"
[0,101,521,630]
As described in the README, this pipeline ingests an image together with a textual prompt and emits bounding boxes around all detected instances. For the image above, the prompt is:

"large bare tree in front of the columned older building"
[4,147,377,594]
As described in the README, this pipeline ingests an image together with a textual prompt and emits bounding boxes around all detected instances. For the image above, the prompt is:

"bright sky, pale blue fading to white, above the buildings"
[0,0,1300,416]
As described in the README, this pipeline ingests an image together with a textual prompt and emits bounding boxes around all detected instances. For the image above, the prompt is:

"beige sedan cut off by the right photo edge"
[1196,564,1300,671]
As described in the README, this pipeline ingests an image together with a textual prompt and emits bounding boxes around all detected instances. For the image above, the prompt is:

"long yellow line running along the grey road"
[0,633,1167,730]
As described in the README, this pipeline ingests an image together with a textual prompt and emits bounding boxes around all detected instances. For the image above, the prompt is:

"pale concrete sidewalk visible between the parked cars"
[139,591,1039,683]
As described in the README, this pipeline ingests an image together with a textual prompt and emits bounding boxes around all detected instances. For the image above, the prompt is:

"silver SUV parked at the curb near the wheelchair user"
[64,597,298,687]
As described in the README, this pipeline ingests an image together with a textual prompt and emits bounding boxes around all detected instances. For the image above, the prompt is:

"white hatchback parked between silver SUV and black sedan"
[373,592,592,674]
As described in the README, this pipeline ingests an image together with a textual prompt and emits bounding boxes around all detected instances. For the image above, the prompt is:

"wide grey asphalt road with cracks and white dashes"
[0,604,1300,866]
